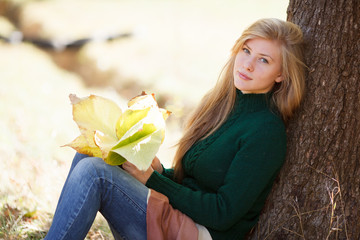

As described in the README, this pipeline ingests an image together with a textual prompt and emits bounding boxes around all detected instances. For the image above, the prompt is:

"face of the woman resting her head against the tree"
[233,38,283,93]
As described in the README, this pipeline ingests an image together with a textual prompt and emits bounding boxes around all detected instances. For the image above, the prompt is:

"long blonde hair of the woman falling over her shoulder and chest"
[174,18,305,182]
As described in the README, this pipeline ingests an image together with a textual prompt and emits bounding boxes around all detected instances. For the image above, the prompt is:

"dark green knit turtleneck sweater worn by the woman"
[146,91,286,240]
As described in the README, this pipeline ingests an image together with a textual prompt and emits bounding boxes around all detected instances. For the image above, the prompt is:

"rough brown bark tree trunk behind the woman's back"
[248,0,360,239]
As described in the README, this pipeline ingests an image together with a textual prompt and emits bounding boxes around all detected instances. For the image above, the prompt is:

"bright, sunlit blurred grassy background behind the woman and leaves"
[0,0,289,239]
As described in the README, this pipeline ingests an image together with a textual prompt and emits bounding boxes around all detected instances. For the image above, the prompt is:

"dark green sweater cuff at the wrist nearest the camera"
[145,171,180,196]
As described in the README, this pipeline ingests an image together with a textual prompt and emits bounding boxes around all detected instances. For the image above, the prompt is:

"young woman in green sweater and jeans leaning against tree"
[46,19,304,240]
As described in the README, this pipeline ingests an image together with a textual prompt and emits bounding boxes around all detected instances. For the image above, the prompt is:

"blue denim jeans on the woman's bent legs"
[45,153,149,240]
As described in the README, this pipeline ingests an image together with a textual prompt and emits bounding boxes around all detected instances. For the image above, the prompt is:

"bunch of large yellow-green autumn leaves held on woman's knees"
[65,92,170,170]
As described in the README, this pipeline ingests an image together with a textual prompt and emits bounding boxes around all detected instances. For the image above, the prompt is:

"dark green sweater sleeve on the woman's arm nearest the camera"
[146,122,286,231]
